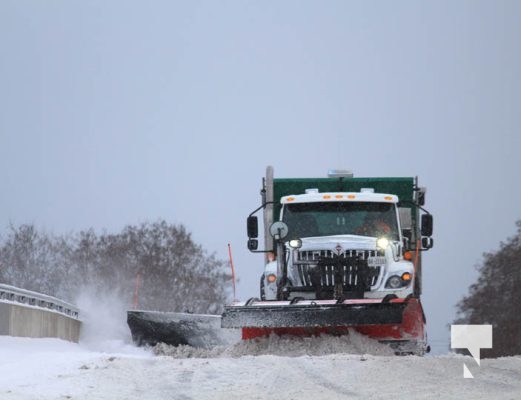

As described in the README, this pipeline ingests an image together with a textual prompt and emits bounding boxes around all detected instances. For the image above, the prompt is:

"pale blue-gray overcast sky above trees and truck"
[0,0,521,354]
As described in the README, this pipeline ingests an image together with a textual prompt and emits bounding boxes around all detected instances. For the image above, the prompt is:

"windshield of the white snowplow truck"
[282,202,399,240]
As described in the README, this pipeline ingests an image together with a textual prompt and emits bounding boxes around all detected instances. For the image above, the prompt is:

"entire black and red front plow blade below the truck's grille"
[222,298,428,355]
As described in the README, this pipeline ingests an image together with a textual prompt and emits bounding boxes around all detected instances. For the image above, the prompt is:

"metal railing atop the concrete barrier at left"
[0,283,80,319]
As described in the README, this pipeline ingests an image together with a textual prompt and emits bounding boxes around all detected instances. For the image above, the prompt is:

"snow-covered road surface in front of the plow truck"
[0,337,521,400]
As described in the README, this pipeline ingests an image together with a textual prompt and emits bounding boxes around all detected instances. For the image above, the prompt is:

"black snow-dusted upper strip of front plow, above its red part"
[222,300,407,328]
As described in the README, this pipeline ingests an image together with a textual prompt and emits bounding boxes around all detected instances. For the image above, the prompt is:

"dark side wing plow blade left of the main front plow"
[127,311,240,348]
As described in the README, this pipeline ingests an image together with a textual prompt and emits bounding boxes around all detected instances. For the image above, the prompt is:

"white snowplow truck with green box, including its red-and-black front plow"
[221,167,433,355]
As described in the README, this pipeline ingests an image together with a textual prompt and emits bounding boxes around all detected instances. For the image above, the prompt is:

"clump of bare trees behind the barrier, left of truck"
[0,221,230,312]
